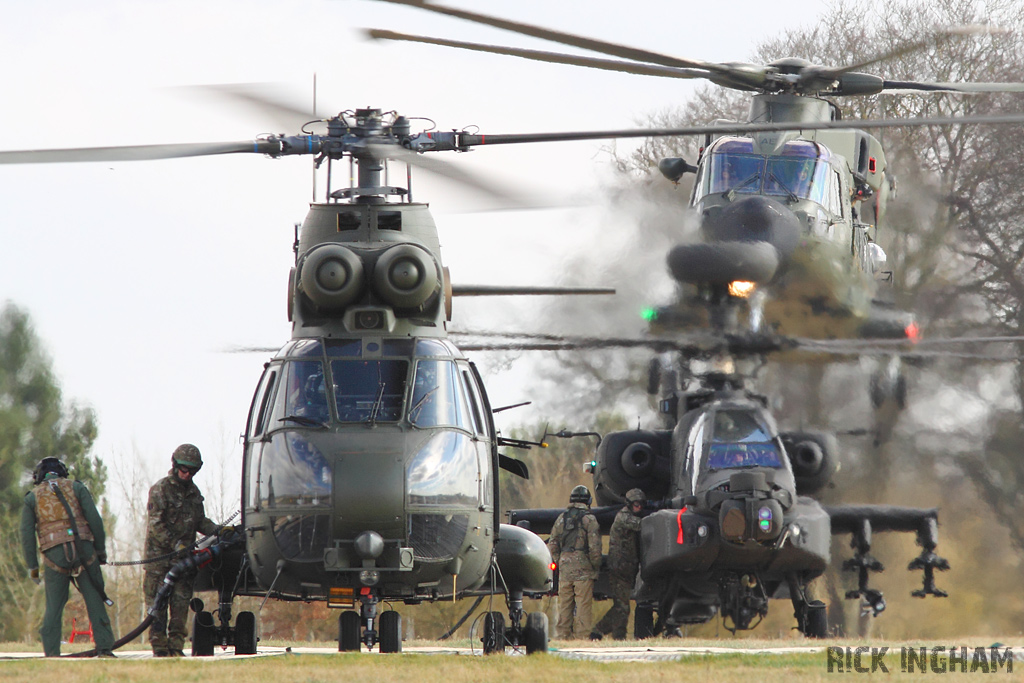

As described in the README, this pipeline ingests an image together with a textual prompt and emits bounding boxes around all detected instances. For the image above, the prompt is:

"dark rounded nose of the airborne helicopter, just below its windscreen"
[701,195,801,256]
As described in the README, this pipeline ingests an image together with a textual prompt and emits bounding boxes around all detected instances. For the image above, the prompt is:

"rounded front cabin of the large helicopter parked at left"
[243,337,512,600]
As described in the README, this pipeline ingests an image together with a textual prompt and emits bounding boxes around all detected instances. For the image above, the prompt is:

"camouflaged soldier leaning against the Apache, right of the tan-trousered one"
[590,488,646,640]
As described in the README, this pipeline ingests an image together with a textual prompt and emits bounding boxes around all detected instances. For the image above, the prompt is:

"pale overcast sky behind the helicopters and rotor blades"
[0,0,827,507]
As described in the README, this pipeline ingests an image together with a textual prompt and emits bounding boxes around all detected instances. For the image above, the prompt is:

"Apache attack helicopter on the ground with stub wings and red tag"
[491,336,949,638]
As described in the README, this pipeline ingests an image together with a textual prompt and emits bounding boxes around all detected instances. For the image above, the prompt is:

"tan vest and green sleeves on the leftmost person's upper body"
[20,477,106,569]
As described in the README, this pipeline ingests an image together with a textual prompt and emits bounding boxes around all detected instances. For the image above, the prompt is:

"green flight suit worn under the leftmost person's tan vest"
[22,474,114,657]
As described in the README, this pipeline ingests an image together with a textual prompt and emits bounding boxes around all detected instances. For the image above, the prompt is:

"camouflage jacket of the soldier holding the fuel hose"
[145,470,219,557]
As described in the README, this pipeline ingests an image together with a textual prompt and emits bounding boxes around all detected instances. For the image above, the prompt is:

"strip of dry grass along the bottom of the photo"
[0,638,1011,683]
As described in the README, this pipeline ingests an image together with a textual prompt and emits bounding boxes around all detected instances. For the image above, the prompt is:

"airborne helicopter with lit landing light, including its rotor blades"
[367,0,1024,362]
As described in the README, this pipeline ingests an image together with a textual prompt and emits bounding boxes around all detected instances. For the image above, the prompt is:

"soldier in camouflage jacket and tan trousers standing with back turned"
[548,486,601,640]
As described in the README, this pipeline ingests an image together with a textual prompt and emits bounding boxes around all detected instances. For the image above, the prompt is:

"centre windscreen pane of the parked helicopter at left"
[331,358,409,422]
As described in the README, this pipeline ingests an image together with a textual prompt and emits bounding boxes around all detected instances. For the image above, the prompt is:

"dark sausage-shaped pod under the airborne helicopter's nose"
[669,242,778,285]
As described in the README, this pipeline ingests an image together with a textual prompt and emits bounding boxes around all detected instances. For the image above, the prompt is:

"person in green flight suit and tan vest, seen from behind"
[22,457,114,657]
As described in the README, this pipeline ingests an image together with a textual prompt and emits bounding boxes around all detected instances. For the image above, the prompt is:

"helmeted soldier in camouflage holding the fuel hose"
[144,443,223,657]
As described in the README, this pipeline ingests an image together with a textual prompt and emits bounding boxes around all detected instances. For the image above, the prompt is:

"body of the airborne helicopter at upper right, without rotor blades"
[667,94,905,338]
